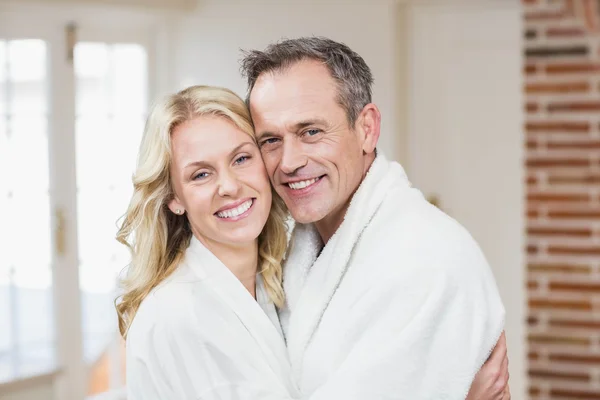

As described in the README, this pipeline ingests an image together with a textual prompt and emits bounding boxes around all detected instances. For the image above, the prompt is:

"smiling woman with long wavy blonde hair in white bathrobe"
[117,86,296,400]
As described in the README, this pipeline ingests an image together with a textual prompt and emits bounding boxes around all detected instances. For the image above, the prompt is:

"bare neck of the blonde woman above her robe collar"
[198,237,258,298]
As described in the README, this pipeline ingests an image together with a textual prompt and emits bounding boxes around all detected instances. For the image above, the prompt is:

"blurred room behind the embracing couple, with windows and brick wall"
[0,0,600,400]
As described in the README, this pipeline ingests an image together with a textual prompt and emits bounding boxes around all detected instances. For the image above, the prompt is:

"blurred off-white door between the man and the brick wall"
[407,0,525,399]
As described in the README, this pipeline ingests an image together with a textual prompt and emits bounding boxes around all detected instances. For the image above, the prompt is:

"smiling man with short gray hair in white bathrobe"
[242,38,510,400]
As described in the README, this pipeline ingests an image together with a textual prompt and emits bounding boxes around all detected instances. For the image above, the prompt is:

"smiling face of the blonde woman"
[169,116,271,248]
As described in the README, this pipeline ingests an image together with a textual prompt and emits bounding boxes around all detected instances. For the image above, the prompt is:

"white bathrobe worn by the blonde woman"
[126,239,297,400]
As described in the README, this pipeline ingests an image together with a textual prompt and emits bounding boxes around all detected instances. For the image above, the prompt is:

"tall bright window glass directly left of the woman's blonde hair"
[75,43,147,394]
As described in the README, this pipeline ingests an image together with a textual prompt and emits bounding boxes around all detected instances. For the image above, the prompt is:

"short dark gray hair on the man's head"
[241,37,373,126]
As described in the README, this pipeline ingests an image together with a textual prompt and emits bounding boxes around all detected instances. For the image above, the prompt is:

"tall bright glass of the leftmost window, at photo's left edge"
[0,40,54,366]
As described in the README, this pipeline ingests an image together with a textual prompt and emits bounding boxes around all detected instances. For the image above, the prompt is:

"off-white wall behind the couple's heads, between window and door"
[162,0,397,162]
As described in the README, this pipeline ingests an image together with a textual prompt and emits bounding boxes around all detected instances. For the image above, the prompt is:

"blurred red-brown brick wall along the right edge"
[516,0,600,400]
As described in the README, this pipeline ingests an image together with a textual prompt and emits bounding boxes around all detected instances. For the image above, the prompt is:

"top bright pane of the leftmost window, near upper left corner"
[8,40,47,115]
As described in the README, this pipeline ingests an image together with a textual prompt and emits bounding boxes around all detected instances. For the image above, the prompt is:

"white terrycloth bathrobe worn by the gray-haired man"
[280,155,504,400]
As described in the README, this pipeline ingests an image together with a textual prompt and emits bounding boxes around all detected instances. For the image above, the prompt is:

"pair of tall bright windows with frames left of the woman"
[0,22,149,395]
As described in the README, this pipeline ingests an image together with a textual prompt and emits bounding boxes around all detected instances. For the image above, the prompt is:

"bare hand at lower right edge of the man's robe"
[466,333,510,400]
